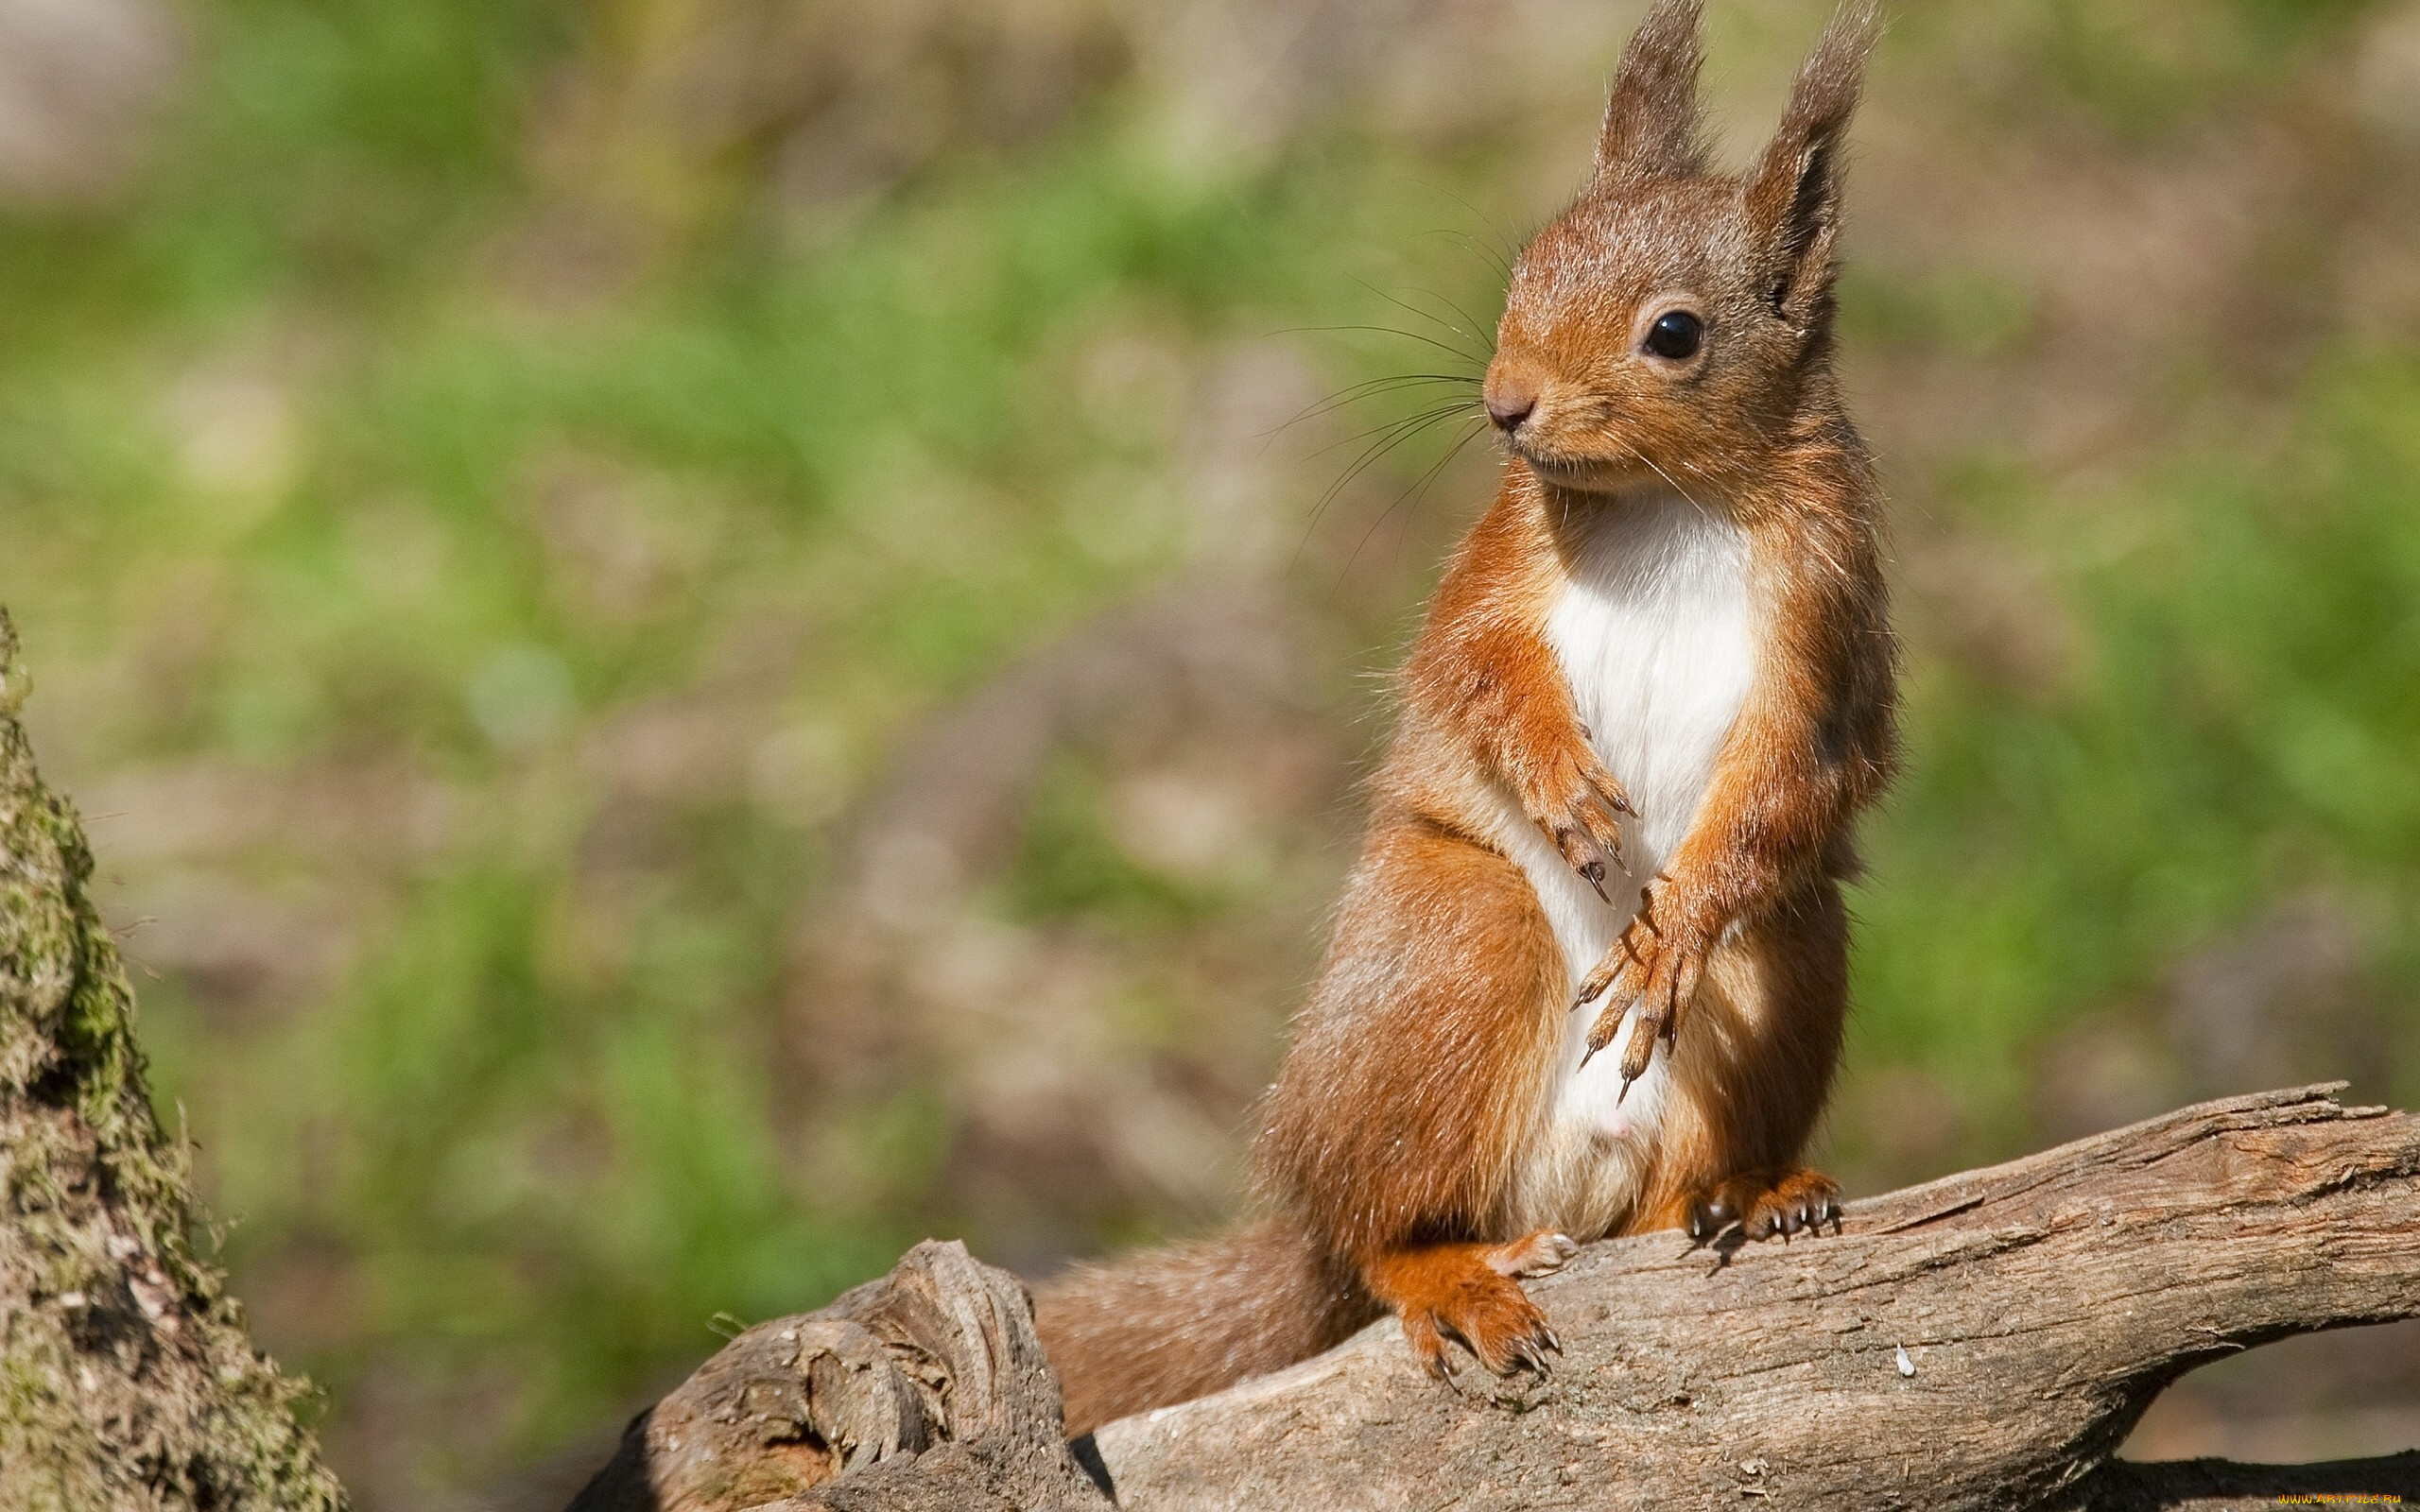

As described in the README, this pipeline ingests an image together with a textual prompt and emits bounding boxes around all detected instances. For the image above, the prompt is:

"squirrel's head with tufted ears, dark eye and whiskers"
[1486,0,1880,491]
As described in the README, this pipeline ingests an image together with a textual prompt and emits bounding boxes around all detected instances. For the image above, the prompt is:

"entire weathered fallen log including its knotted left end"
[576,1086,2420,1512]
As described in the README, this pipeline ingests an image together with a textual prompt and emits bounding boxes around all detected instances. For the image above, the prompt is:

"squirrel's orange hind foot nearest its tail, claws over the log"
[1367,1228,1578,1382]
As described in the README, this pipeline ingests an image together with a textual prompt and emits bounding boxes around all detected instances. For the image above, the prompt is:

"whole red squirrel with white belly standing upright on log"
[1036,0,1897,1435]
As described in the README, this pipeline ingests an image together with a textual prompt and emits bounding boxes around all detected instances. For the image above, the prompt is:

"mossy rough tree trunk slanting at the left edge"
[0,612,344,1512]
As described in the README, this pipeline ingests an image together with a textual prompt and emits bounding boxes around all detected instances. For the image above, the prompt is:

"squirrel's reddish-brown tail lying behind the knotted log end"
[1033,1219,1382,1437]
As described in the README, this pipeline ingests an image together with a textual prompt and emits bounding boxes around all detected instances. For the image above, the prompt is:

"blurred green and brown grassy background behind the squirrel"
[0,0,2420,1512]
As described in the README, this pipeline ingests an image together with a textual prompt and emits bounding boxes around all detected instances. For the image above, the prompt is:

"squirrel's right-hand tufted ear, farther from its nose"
[1745,0,1883,329]
